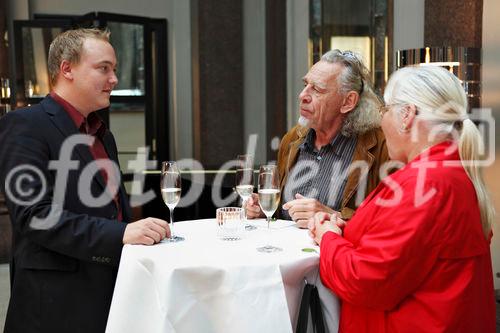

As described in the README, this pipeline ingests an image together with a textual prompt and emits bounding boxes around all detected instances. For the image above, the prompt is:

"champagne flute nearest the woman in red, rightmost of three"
[257,165,282,253]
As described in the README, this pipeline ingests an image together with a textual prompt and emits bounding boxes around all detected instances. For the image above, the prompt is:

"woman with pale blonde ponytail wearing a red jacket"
[309,67,495,333]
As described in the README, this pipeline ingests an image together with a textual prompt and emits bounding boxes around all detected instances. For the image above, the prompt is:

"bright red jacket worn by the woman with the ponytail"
[320,142,495,333]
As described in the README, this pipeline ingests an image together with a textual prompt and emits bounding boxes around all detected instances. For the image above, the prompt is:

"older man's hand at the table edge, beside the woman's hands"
[283,193,334,228]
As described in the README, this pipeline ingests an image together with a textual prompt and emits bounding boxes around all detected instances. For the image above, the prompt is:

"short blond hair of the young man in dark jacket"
[48,28,110,85]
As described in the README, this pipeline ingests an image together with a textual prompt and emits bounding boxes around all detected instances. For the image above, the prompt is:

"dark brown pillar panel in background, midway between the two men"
[191,0,244,169]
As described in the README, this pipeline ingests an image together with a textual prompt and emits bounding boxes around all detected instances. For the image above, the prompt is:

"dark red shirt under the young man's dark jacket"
[50,92,123,221]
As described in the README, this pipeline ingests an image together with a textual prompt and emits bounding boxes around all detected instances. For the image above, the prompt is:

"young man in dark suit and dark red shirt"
[0,29,170,332]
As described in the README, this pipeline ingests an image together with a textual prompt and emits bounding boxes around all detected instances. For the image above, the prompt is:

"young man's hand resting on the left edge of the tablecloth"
[123,217,170,245]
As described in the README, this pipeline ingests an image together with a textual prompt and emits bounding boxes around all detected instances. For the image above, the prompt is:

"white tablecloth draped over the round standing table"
[106,219,339,333]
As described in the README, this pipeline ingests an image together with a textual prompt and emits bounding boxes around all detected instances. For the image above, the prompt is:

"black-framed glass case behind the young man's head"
[9,12,169,174]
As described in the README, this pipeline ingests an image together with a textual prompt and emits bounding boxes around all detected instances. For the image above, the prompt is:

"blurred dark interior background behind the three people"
[0,0,500,326]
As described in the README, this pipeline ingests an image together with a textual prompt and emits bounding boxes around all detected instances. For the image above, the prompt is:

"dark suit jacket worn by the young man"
[0,96,130,333]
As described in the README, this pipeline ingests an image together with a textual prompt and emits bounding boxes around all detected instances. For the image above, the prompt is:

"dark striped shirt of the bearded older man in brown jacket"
[282,129,357,219]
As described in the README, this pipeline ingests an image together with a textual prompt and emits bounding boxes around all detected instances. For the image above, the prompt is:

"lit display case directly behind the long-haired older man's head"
[309,0,393,93]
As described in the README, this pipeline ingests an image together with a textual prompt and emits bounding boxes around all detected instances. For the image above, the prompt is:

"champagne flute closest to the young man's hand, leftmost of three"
[160,161,184,242]
